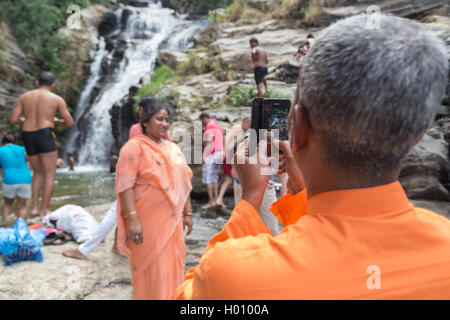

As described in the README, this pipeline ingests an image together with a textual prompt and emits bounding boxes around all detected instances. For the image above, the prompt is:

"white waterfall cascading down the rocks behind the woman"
[66,0,208,166]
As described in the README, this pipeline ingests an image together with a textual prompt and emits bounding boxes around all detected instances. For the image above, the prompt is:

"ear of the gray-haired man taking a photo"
[292,104,311,153]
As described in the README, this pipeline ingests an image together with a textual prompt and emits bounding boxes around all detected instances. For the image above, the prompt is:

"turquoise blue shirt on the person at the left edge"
[0,144,31,184]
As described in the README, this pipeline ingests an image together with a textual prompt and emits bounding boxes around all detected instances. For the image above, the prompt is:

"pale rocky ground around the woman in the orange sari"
[0,203,226,300]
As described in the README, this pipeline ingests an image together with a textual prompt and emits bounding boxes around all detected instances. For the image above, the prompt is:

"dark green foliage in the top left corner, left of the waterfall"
[3,0,108,78]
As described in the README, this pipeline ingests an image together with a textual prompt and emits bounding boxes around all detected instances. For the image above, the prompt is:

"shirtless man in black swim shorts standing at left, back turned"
[11,72,73,218]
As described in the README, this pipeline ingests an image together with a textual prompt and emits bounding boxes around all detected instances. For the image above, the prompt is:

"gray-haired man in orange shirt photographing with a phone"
[174,15,450,299]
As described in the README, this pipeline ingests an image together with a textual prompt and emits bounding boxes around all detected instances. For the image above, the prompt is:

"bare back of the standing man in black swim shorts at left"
[20,89,65,131]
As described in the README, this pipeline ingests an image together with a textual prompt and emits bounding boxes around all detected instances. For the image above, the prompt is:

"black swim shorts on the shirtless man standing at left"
[22,128,56,156]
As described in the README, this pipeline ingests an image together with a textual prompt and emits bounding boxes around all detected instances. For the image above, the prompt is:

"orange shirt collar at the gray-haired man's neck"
[307,181,412,217]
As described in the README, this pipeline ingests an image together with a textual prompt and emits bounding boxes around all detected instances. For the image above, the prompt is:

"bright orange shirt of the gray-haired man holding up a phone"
[176,182,450,299]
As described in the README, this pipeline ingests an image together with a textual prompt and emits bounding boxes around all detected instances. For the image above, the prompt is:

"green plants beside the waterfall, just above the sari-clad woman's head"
[134,65,179,113]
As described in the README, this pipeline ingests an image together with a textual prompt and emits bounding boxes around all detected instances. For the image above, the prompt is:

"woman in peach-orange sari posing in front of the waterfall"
[116,98,193,300]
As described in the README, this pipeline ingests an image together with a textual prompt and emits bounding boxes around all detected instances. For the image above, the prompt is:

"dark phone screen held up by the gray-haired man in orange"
[261,99,291,140]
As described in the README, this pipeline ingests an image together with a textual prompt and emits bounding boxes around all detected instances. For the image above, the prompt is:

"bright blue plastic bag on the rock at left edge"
[0,218,45,266]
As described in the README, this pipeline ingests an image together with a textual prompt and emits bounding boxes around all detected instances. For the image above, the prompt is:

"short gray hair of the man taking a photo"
[299,14,448,177]
